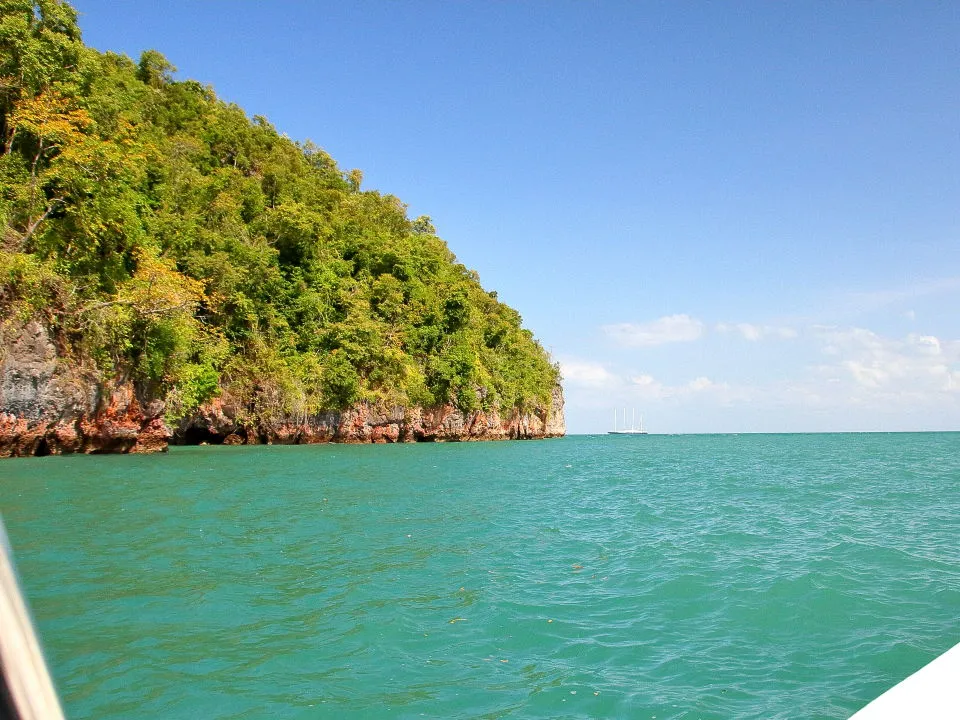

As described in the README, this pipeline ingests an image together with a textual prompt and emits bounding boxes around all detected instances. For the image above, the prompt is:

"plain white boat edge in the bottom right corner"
[850,643,960,720]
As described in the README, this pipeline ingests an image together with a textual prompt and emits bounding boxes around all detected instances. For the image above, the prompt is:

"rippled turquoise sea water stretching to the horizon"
[0,433,960,719]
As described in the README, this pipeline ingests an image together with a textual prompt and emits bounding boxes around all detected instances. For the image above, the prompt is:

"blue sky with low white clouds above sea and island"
[74,0,960,434]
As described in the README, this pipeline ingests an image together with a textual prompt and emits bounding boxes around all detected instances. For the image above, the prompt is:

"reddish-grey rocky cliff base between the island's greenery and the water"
[0,322,565,457]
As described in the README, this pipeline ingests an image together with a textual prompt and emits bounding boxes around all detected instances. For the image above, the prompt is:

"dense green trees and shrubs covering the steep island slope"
[0,0,558,428]
